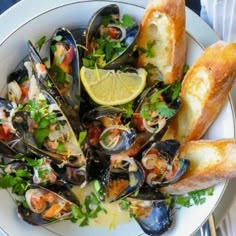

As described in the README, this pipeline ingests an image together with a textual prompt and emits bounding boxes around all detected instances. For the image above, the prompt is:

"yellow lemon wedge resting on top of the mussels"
[80,66,147,106]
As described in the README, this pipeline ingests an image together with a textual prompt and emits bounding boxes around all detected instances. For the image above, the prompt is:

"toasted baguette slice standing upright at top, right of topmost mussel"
[137,0,186,84]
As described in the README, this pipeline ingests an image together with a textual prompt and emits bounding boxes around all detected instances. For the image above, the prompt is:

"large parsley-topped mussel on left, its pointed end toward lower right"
[12,90,86,167]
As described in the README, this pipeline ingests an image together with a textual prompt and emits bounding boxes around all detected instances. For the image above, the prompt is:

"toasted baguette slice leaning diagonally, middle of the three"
[163,41,236,143]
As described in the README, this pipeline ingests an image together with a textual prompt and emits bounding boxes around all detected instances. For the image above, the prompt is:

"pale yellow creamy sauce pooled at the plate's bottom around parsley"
[72,183,132,229]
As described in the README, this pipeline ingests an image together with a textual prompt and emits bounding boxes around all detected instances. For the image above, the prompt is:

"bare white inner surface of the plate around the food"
[0,1,234,236]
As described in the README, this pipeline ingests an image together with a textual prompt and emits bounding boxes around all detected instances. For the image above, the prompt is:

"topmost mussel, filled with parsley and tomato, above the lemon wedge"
[83,4,139,69]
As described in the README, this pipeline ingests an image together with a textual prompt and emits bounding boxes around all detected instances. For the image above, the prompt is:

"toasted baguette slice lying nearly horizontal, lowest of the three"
[161,139,236,195]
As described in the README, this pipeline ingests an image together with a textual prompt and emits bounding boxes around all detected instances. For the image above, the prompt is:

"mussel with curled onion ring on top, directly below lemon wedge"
[82,106,136,154]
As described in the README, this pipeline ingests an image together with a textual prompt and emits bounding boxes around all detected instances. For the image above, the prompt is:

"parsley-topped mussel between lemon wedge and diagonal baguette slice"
[126,83,181,156]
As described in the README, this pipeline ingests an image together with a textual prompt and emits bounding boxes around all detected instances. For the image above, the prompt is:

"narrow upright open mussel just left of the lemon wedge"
[50,28,80,110]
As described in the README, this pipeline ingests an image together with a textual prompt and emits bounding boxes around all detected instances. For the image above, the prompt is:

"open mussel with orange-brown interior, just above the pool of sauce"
[99,155,144,202]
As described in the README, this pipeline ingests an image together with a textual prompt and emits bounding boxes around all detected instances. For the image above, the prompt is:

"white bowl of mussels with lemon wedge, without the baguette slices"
[0,1,233,236]
